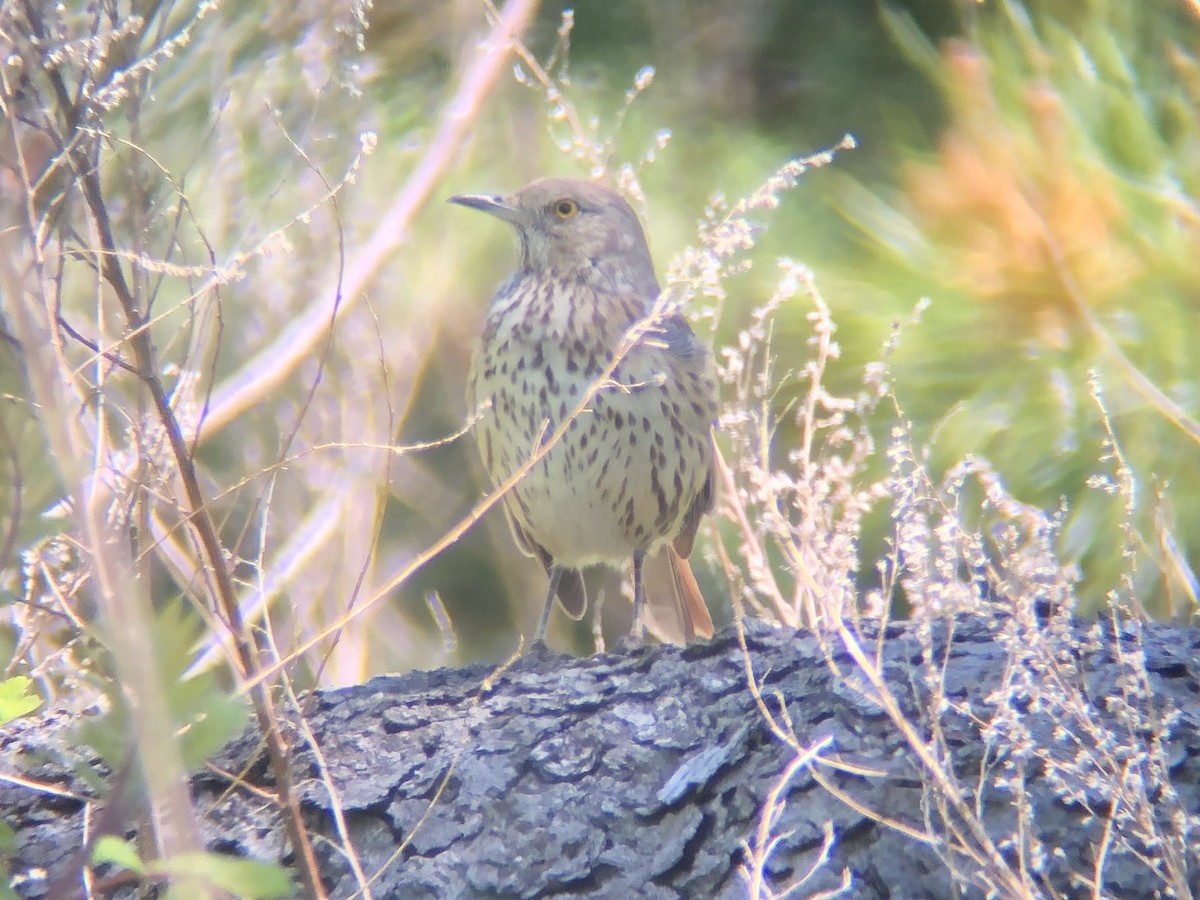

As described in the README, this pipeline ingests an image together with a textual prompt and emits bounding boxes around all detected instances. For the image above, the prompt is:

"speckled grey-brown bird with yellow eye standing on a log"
[450,178,718,646]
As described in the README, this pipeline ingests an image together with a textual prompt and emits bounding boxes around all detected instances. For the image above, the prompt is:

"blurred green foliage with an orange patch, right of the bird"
[827,0,1200,614]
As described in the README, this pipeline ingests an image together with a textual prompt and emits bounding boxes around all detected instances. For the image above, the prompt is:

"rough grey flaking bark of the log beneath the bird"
[0,620,1200,898]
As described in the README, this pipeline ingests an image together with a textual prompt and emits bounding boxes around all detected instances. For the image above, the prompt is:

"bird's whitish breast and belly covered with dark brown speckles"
[468,277,716,568]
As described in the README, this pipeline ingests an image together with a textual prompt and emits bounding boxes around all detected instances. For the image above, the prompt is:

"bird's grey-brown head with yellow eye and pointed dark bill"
[450,178,658,294]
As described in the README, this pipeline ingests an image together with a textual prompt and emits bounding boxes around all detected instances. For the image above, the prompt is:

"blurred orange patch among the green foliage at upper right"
[905,44,1140,344]
